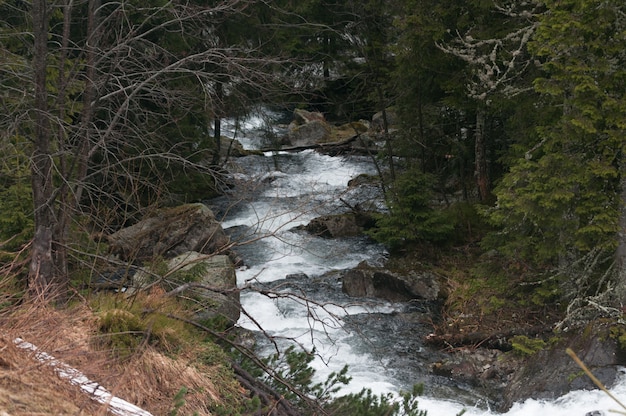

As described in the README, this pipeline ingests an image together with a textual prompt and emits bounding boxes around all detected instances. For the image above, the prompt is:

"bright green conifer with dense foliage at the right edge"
[491,0,626,312]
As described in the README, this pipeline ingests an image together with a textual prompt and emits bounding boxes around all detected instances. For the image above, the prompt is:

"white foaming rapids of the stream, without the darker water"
[217,112,626,416]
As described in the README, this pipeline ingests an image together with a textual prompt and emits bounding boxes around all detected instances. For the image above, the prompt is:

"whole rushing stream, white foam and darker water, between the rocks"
[208,112,626,416]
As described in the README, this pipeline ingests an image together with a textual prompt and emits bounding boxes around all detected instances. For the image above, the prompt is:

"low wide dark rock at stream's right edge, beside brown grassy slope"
[342,263,440,302]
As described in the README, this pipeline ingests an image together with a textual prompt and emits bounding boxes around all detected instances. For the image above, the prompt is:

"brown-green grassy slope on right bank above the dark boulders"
[391,244,563,351]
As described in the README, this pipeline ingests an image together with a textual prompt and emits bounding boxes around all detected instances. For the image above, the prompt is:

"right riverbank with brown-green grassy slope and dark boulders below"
[388,245,626,413]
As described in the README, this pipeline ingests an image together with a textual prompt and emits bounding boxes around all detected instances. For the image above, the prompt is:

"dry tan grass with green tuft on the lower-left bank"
[0,293,246,415]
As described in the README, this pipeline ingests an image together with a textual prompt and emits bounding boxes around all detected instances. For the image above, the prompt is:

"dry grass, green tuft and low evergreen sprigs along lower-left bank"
[0,280,444,416]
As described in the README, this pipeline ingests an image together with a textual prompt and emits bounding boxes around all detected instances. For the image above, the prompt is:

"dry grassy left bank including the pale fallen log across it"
[0,300,242,416]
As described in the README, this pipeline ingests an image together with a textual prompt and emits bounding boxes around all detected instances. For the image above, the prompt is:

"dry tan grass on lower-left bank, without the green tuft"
[0,294,241,416]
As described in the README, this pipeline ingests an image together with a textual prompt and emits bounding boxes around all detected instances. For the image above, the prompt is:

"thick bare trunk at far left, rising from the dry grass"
[28,0,61,299]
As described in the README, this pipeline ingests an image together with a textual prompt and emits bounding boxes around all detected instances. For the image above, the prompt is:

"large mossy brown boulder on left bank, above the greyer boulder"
[107,203,230,262]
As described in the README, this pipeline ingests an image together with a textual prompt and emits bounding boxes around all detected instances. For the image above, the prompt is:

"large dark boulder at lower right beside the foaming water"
[427,321,626,416]
